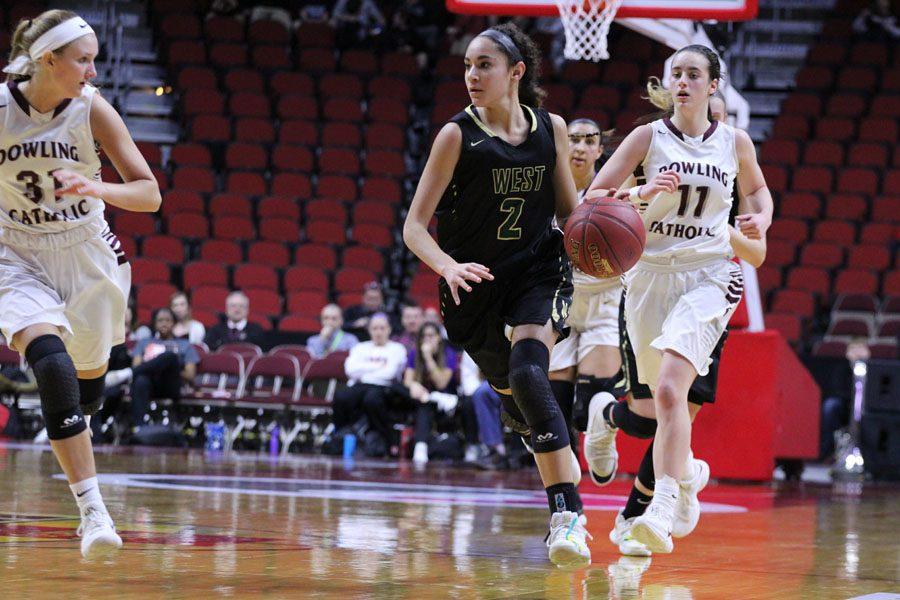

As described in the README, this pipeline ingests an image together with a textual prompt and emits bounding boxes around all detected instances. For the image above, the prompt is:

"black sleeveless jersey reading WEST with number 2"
[435,105,556,277]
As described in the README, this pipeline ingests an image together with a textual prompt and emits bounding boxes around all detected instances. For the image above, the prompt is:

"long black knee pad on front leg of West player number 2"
[509,338,569,453]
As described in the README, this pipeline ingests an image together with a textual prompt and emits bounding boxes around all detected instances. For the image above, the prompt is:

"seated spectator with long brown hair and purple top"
[403,323,459,463]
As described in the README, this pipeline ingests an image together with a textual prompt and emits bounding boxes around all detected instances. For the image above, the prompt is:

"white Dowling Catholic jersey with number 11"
[635,119,738,264]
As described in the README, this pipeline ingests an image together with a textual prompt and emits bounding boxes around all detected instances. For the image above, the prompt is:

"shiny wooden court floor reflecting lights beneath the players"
[0,444,900,600]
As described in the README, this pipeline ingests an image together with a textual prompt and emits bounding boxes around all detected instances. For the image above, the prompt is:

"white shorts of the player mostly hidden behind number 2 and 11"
[550,285,622,371]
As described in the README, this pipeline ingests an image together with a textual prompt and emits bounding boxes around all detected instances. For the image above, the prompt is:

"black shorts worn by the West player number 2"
[438,236,572,389]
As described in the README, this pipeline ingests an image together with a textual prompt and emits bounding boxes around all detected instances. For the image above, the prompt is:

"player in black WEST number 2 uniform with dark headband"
[403,24,590,566]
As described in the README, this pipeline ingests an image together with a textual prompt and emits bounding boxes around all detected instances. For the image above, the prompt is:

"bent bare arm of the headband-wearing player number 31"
[53,94,162,212]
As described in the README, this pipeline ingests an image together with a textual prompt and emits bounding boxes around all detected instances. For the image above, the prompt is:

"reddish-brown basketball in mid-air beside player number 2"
[565,198,646,278]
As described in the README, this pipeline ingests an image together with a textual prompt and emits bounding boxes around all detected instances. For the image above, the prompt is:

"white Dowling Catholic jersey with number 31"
[0,82,104,234]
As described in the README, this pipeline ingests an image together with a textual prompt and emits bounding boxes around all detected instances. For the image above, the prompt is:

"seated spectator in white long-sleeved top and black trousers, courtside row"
[332,313,407,455]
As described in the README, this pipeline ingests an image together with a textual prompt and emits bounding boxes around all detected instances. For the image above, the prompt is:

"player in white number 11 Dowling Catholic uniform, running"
[590,45,771,553]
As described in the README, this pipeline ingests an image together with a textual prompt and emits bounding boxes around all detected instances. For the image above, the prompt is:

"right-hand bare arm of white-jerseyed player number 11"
[735,129,775,241]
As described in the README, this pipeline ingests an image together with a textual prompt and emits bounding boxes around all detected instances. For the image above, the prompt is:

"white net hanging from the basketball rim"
[556,0,623,62]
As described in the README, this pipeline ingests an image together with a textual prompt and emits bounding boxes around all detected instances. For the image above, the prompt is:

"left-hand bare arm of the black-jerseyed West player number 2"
[403,123,494,304]
